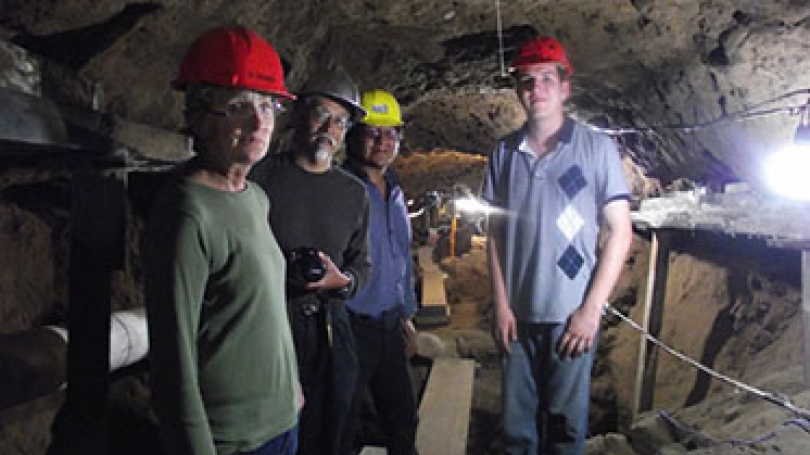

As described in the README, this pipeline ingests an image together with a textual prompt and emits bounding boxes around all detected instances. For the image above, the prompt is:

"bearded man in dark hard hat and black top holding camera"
[255,69,371,455]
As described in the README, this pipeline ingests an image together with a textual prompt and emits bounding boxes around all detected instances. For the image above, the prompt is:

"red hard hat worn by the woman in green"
[172,27,295,99]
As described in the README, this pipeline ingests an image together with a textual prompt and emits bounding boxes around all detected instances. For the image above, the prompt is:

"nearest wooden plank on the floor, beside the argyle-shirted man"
[416,357,475,455]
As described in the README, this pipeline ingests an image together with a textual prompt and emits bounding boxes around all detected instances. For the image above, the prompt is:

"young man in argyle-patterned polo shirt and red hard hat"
[482,36,632,455]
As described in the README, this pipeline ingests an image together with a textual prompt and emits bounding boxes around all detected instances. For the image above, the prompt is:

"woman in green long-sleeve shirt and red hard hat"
[143,27,302,455]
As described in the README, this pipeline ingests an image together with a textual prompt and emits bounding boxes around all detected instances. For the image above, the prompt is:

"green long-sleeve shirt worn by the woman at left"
[144,178,299,455]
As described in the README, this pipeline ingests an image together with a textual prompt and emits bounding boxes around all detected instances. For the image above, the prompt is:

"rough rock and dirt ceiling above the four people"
[0,0,810,186]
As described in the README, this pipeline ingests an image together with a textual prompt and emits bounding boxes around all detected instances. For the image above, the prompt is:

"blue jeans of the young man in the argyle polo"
[503,323,596,455]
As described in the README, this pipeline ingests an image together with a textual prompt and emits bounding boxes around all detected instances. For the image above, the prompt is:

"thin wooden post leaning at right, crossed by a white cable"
[633,230,670,416]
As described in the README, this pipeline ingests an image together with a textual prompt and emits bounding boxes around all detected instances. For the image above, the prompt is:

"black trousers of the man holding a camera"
[290,305,357,455]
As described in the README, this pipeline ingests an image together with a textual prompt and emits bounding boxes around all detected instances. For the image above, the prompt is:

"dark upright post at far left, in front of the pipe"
[48,164,126,455]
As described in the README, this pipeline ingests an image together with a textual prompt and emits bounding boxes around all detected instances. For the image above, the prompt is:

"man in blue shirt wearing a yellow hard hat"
[344,90,417,455]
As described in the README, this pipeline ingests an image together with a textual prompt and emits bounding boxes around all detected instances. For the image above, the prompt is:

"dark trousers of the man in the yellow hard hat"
[350,310,417,455]
